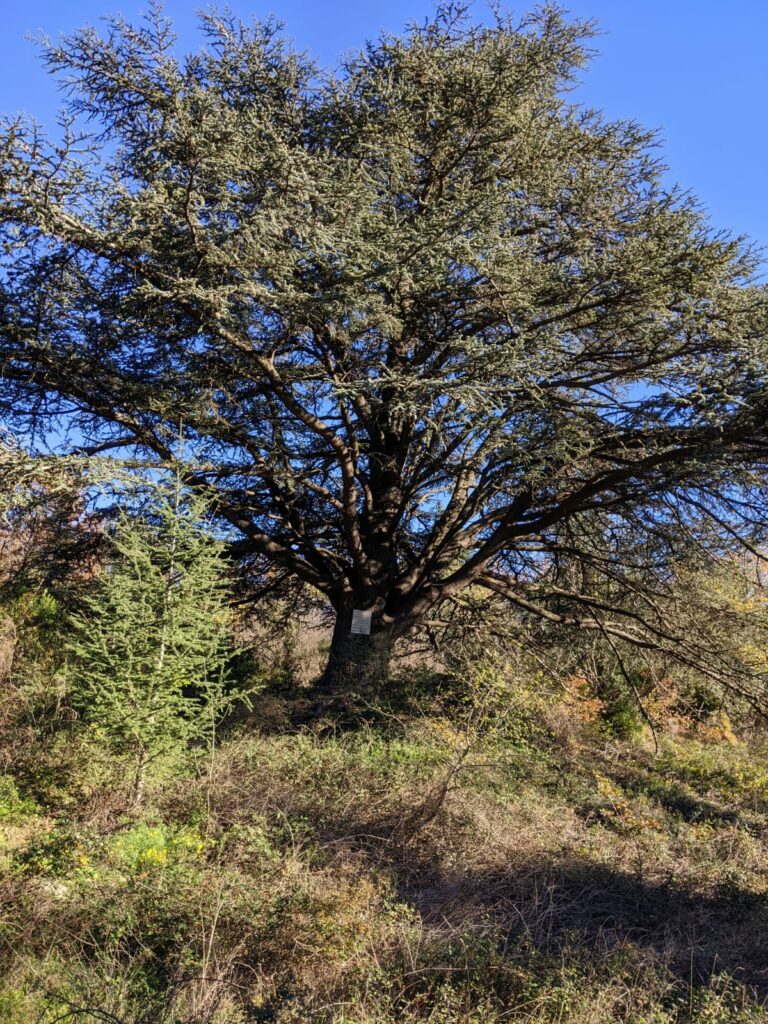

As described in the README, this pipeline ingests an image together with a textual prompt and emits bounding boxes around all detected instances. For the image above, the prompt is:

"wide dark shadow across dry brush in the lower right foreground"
[401,861,768,999]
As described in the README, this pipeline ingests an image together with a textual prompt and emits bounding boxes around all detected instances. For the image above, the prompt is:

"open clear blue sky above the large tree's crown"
[0,0,768,256]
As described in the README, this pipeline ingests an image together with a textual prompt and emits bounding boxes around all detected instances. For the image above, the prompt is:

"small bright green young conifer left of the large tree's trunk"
[69,478,232,799]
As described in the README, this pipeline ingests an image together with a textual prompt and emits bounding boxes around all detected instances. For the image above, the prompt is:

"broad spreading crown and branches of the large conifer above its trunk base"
[0,7,768,678]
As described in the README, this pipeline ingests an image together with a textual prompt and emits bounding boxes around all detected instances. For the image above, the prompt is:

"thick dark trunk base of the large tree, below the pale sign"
[322,608,394,696]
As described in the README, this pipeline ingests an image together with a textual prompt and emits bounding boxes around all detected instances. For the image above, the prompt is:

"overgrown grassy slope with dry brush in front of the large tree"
[0,671,768,1024]
